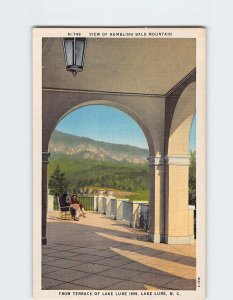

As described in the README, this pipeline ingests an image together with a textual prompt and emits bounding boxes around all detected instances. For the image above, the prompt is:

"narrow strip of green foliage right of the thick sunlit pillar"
[189,151,196,206]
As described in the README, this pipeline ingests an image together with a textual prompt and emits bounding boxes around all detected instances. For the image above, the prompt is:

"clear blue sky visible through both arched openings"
[56,105,196,150]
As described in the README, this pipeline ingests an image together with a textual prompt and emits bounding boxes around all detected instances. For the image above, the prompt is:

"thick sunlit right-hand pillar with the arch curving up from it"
[165,82,196,243]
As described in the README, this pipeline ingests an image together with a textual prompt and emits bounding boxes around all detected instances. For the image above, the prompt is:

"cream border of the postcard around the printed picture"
[33,28,206,300]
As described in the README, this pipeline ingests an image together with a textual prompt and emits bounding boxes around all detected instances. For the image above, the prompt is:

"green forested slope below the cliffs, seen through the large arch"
[48,154,149,194]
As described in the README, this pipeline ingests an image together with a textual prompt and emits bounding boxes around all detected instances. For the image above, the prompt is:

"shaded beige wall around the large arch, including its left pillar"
[42,89,165,243]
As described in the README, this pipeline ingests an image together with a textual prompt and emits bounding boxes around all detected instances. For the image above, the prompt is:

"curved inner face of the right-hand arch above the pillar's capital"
[168,82,196,156]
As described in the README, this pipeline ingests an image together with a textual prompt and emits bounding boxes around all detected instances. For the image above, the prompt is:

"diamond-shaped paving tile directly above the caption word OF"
[72,275,120,290]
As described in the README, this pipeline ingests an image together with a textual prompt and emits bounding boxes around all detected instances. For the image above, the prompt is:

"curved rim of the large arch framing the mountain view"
[43,100,155,155]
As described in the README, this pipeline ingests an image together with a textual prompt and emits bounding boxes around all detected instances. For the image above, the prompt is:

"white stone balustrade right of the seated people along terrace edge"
[94,195,149,230]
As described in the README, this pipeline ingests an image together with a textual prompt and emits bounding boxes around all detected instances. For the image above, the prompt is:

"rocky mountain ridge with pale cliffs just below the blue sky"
[49,130,148,164]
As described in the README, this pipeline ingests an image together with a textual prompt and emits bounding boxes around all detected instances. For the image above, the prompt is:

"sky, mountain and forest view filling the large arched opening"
[48,104,150,229]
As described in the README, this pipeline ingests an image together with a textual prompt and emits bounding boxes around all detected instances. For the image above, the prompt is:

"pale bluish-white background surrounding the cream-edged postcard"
[0,0,233,300]
